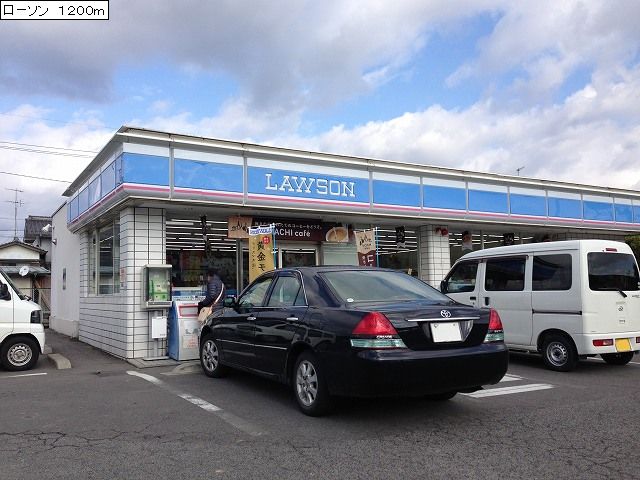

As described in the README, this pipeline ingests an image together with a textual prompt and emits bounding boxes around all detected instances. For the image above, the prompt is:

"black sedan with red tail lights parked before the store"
[200,266,508,415]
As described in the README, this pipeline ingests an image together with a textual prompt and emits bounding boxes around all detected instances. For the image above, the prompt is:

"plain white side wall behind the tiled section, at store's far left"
[49,208,80,338]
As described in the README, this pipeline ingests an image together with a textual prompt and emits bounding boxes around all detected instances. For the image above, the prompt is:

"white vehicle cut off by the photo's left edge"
[0,270,44,371]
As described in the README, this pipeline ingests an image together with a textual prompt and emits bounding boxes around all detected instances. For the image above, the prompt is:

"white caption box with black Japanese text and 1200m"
[0,0,109,20]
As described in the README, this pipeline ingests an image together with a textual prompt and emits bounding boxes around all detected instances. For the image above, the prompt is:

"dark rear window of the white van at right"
[587,252,640,290]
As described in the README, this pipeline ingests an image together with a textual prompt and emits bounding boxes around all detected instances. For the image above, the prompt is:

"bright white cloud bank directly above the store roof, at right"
[271,63,640,189]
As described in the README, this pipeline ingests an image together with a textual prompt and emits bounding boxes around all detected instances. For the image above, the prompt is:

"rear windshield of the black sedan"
[321,270,451,303]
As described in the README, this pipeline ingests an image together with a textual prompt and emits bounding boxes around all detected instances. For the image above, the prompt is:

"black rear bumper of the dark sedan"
[325,343,509,397]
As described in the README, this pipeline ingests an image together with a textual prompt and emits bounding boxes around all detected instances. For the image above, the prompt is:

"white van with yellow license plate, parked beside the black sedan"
[440,240,640,371]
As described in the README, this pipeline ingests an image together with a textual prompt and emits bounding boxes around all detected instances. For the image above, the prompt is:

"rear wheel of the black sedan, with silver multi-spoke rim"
[292,352,333,417]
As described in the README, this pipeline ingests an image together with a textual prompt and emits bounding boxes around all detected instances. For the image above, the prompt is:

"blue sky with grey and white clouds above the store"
[0,0,640,241]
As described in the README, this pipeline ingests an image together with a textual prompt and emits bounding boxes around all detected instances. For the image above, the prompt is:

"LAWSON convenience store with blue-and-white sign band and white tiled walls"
[52,127,640,358]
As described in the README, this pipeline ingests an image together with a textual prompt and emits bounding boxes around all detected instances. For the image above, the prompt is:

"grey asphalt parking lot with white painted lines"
[0,332,640,479]
